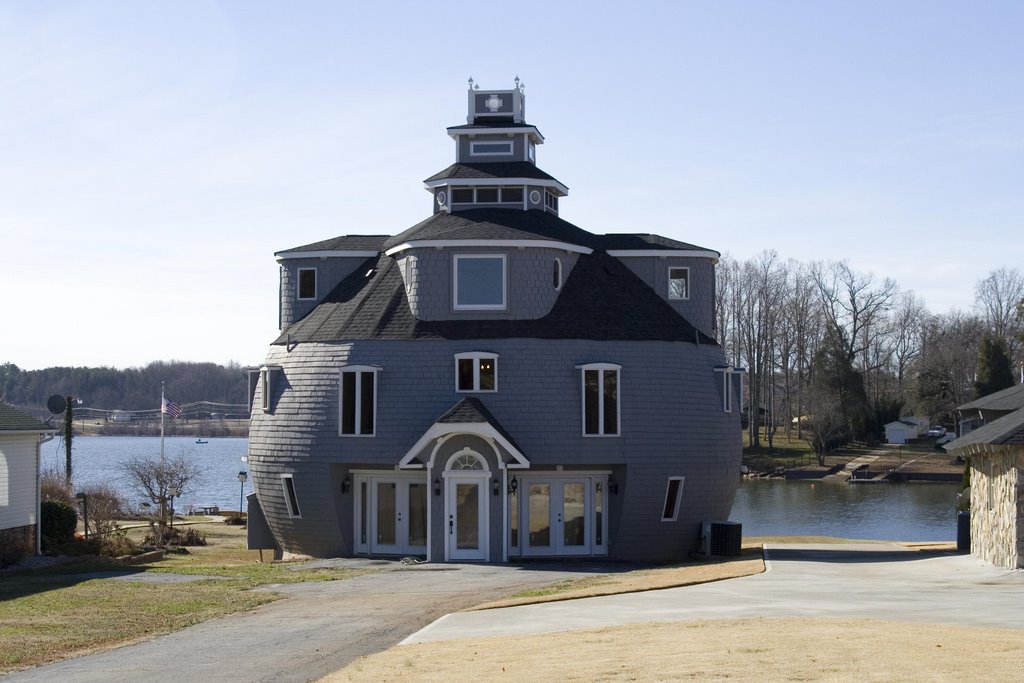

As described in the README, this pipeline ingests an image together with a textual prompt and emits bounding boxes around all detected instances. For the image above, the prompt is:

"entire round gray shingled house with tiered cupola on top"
[249,79,741,562]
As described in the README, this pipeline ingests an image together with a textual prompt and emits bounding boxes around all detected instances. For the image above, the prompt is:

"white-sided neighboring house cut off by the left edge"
[0,403,55,557]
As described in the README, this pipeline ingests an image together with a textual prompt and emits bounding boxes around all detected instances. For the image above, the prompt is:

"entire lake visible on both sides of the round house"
[42,436,958,541]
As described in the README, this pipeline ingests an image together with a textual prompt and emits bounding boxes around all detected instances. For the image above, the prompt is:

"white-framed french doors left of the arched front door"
[355,475,430,555]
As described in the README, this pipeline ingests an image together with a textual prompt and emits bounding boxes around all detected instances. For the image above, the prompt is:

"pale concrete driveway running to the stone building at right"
[402,544,1024,644]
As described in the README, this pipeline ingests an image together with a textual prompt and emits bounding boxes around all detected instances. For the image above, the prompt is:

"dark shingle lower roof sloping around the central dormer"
[274,248,717,344]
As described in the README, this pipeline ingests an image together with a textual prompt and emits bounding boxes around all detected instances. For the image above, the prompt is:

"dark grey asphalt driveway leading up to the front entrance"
[0,560,606,683]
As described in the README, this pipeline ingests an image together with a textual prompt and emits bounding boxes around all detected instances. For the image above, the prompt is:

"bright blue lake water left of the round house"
[42,436,252,510]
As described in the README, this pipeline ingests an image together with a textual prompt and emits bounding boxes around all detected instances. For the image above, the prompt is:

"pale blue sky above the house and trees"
[0,1,1024,369]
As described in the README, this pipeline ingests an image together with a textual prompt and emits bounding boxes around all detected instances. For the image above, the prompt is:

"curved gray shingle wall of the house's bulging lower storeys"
[249,339,740,560]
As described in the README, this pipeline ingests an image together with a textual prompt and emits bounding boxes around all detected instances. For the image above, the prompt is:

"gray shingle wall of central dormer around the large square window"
[398,247,579,321]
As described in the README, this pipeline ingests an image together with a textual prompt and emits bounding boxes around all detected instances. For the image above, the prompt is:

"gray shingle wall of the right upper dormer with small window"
[620,256,716,337]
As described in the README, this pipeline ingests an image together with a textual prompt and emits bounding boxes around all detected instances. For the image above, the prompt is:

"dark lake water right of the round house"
[729,479,959,541]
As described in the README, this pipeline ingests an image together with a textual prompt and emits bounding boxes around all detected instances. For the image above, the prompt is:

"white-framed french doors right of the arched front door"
[520,474,607,555]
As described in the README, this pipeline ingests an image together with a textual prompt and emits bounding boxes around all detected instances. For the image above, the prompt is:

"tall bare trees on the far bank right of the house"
[716,258,1024,459]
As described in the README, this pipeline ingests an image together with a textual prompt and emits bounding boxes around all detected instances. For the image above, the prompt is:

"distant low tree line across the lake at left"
[0,360,249,411]
